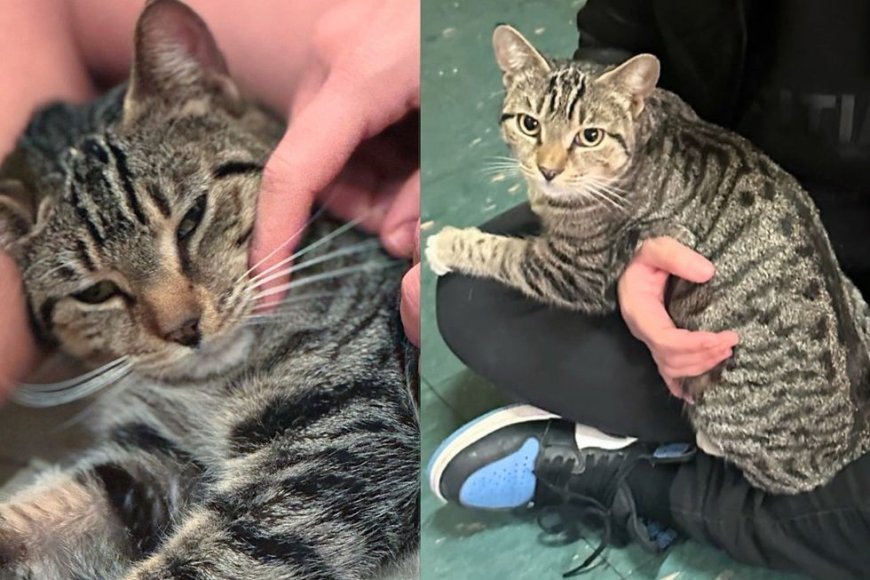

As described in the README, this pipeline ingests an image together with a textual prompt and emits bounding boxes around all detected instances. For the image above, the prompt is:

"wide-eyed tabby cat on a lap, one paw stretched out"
[426,26,870,493]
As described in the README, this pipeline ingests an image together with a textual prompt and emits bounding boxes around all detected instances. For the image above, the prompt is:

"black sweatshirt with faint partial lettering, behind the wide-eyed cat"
[577,0,870,191]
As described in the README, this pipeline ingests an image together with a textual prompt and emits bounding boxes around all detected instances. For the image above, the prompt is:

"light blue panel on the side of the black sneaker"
[459,437,541,509]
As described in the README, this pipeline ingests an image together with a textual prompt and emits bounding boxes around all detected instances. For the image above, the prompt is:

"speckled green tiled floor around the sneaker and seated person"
[422,0,804,580]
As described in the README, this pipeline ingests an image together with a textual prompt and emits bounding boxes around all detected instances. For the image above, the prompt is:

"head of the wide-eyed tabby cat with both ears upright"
[493,26,659,198]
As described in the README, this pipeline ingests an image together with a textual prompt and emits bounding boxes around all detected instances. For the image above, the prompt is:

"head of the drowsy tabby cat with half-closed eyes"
[0,0,276,374]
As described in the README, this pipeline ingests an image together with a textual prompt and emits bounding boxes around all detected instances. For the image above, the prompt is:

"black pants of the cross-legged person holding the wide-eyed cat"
[437,205,870,580]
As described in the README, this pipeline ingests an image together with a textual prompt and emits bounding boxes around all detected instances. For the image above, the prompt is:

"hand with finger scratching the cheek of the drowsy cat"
[251,0,420,341]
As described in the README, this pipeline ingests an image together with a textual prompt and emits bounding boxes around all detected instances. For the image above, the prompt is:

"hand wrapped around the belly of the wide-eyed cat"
[618,238,739,398]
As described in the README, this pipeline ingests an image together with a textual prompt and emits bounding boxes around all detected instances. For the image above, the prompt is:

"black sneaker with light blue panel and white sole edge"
[428,405,694,576]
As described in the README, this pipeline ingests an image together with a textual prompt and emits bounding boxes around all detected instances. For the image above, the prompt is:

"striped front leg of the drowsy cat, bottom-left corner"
[0,428,203,580]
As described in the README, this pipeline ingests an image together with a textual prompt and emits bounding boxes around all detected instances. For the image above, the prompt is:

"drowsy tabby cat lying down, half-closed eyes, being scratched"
[0,0,419,580]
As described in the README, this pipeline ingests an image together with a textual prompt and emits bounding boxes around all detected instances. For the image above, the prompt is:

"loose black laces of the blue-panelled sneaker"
[535,425,650,578]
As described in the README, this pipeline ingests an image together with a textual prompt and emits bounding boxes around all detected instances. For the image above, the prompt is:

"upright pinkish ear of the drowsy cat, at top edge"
[124,0,242,126]
